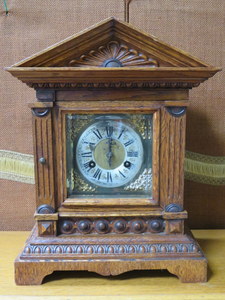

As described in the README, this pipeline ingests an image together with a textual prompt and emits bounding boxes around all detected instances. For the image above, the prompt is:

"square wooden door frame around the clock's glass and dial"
[55,101,161,210]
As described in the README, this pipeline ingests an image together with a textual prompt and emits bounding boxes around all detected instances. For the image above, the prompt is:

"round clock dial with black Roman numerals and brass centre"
[76,117,144,188]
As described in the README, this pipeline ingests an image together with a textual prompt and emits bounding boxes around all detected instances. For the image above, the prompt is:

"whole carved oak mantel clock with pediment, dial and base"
[8,18,219,284]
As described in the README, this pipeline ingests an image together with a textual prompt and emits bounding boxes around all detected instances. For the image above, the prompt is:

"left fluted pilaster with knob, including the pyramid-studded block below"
[29,102,58,237]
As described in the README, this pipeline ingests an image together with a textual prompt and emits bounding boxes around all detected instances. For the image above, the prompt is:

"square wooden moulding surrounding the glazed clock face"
[57,101,159,210]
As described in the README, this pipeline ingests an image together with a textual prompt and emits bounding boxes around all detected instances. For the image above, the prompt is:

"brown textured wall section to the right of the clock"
[130,0,225,228]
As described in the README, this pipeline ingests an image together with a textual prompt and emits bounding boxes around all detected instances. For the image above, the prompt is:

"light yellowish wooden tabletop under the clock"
[0,230,225,300]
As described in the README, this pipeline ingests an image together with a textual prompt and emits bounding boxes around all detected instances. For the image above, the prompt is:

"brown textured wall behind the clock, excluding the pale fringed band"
[0,0,225,230]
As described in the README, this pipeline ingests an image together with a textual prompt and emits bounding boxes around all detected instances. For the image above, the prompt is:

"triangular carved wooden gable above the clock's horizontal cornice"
[8,18,213,67]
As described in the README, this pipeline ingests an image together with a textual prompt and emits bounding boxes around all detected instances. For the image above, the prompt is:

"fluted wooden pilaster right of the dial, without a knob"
[160,106,186,212]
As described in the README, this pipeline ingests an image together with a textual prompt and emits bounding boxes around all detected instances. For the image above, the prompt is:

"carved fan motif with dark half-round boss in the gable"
[69,41,159,68]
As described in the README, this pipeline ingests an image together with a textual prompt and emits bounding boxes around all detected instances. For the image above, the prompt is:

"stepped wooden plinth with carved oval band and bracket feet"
[15,228,207,285]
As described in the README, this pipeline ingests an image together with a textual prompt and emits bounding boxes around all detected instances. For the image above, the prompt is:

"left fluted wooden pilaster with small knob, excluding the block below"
[29,102,56,213]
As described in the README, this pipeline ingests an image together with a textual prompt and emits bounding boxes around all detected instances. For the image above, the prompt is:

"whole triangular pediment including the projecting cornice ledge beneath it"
[7,18,219,88]
